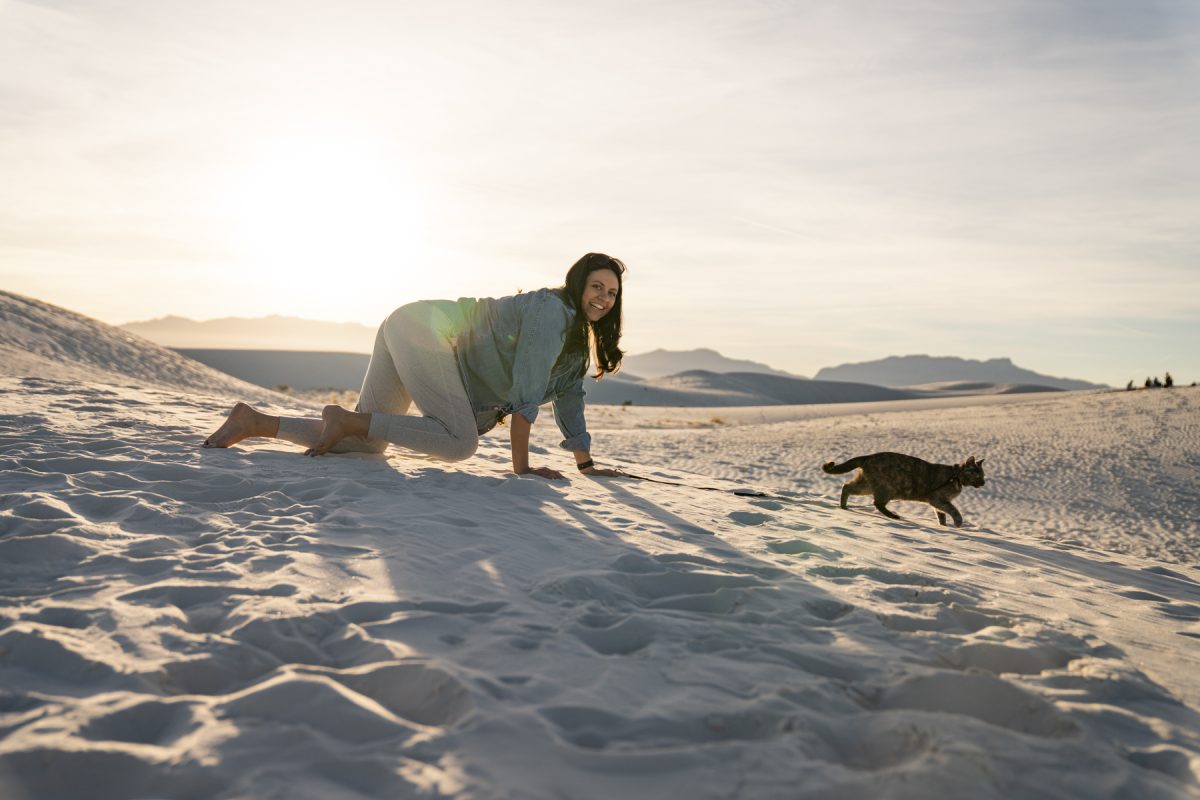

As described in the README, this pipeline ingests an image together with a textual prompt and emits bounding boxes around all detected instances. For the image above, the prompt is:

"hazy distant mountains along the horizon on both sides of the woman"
[121,317,1103,405]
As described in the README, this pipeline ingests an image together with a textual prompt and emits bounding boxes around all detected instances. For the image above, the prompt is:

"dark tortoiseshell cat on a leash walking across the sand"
[821,453,984,528]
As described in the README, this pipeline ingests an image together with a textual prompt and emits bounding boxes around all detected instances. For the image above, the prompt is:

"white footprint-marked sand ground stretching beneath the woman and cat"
[0,295,1200,800]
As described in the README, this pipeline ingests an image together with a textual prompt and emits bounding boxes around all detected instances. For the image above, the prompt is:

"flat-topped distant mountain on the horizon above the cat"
[815,355,1106,390]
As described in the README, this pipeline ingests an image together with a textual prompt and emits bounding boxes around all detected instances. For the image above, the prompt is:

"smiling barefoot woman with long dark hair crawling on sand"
[204,253,625,479]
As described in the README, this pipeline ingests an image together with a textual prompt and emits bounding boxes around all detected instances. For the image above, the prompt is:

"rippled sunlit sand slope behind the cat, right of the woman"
[598,387,1200,566]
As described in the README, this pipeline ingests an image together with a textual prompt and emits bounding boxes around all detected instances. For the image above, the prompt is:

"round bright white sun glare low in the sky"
[226,136,425,313]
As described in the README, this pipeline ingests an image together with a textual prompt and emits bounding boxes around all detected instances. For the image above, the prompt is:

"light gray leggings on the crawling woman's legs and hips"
[277,300,479,461]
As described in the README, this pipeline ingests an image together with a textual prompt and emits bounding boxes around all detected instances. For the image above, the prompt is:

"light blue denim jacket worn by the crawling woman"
[455,289,592,450]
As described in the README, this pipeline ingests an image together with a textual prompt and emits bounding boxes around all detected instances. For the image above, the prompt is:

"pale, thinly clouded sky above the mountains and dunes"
[0,0,1200,385]
